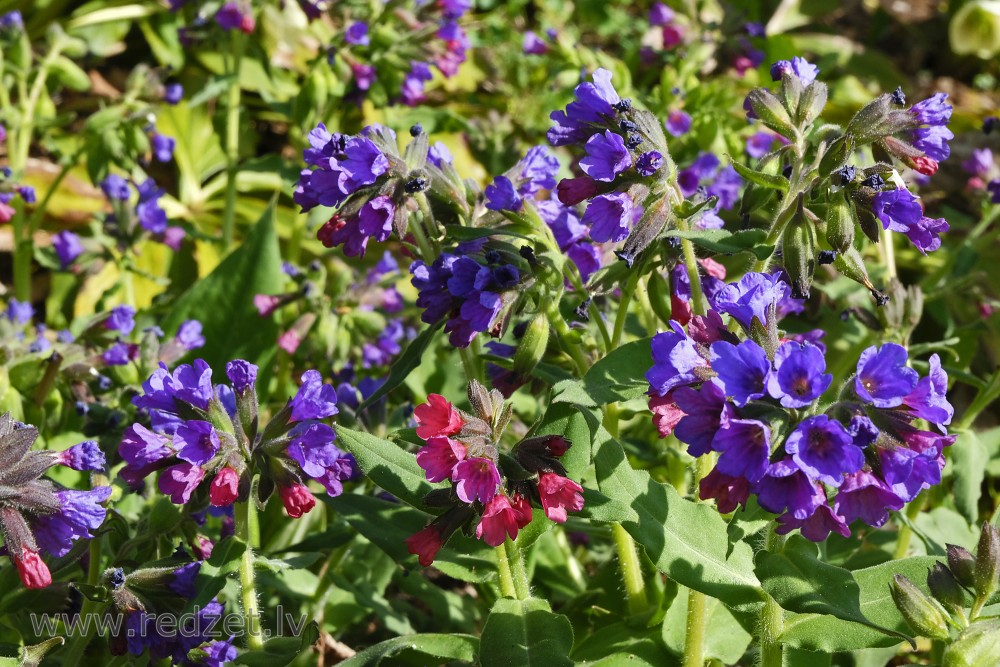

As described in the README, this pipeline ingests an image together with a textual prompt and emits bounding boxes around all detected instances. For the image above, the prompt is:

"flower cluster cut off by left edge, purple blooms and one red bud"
[0,413,111,588]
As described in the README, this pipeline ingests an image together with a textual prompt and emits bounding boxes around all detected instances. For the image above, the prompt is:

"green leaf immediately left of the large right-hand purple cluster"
[552,338,653,408]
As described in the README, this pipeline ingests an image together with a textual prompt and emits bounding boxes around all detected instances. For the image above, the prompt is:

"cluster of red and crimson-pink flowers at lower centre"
[406,381,583,566]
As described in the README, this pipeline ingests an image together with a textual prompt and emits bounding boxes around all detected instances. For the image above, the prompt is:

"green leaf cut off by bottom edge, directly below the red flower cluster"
[480,598,573,667]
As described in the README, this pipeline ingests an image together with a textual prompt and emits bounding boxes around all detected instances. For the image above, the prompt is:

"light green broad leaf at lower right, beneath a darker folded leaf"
[778,556,942,651]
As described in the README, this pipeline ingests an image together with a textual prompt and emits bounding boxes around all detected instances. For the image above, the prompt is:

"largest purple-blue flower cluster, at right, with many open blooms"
[646,273,954,541]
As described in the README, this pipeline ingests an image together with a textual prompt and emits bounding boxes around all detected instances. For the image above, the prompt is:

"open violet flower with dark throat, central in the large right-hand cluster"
[785,415,865,487]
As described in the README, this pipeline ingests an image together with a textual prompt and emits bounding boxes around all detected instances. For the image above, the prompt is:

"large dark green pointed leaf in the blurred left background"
[163,202,284,379]
